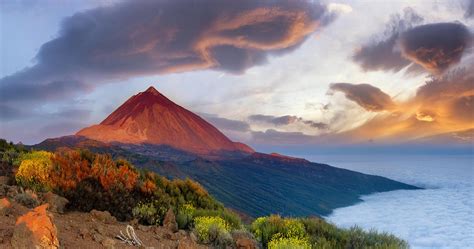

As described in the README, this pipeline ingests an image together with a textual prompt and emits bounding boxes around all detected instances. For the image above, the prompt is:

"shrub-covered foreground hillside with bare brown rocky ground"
[0,139,408,249]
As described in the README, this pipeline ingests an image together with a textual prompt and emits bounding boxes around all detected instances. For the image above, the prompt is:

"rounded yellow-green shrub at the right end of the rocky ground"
[194,216,229,244]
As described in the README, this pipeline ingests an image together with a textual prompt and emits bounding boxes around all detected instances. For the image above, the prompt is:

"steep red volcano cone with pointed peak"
[76,87,254,155]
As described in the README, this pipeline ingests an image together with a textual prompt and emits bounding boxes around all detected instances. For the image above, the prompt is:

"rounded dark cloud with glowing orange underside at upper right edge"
[400,23,471,74]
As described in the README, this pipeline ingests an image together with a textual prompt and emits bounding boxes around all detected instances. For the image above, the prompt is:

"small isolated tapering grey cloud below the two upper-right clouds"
[330,83,396,112]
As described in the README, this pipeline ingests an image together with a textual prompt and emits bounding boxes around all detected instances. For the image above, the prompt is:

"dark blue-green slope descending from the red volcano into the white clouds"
[34,136,418,217]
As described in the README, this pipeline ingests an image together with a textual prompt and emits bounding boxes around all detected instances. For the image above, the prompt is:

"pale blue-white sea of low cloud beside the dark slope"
[300,154,474,249]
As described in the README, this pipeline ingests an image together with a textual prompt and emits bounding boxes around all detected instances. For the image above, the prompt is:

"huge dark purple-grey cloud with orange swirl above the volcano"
[0,0,334,106]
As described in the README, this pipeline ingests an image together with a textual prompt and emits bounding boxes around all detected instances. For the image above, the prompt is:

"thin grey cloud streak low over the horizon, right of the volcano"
[248,114,328,129]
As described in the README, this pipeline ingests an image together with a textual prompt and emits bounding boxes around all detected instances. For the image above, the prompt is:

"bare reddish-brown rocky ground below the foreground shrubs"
[0,176,215,249]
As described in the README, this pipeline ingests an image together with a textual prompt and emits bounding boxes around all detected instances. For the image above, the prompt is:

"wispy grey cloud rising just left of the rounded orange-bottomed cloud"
[352,8,423,72]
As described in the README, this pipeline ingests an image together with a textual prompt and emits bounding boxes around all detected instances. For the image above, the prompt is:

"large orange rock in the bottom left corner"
[11,204,59,249]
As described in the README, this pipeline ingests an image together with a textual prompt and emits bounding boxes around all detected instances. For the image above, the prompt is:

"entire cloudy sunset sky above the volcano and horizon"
[0,0,474,148]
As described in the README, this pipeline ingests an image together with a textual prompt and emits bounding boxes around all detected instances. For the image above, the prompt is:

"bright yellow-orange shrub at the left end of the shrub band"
[15,151,53,191]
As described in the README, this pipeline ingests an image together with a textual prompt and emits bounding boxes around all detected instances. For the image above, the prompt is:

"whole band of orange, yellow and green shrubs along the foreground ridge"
[0,140,408,249]
